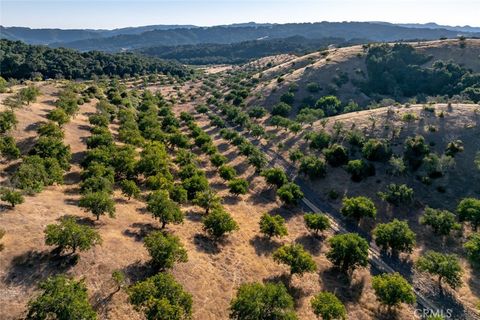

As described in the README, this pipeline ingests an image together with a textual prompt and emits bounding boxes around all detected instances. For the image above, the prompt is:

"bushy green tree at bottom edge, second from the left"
[128,273,193,320]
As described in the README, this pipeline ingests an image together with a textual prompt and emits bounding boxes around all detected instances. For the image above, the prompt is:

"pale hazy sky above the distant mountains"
[0,0,480,29]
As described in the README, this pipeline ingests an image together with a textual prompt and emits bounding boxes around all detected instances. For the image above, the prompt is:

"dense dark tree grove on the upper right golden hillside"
[361,44,480,102]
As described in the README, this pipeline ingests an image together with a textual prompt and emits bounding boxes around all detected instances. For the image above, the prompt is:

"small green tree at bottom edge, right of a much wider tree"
[310,292,347,320]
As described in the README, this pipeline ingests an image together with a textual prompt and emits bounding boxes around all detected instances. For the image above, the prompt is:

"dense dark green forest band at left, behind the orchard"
[0,39,190,79]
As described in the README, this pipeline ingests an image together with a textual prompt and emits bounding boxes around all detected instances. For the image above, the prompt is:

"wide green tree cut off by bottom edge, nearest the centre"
[230,282,297,320]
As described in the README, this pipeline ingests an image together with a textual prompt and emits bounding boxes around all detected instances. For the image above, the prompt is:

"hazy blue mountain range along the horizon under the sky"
[0,22,480,52]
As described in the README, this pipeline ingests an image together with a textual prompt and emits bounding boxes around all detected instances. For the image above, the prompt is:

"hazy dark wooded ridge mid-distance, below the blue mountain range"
[138,36,362,65]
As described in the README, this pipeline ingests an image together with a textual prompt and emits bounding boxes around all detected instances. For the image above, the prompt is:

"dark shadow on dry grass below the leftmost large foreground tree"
[4,249,78,287]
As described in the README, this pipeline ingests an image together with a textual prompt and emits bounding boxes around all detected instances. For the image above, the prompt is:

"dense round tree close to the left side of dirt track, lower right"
[327,233,369,272]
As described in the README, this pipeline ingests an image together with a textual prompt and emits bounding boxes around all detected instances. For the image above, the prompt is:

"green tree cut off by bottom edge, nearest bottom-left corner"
[26,275,97,320]
